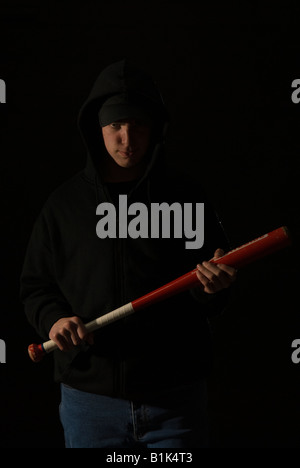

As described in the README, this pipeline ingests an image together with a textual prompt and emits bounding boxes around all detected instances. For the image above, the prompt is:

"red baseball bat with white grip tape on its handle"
[28,226,291,362]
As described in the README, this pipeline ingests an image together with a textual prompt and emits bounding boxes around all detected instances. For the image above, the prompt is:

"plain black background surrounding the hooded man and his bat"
[0,0,300,448]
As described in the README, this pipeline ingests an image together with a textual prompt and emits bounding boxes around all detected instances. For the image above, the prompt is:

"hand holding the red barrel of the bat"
[196,249,237,294]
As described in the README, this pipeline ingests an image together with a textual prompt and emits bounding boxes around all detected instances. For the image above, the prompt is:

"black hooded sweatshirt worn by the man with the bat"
[21,60,228,402]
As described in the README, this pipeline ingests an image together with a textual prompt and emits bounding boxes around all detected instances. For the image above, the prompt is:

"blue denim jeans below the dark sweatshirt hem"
[59,381,208,448]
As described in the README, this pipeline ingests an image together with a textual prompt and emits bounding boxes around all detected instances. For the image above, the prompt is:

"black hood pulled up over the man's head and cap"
[78,59,168,182]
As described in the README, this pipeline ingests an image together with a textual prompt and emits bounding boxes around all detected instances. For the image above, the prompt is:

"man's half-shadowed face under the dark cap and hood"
[102,119,151,169]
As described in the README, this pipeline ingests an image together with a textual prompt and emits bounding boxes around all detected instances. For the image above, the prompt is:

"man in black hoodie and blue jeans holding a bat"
[21,59,236,448]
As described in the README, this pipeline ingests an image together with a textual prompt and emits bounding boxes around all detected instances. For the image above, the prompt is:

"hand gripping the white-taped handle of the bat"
[49,316,93,351]
